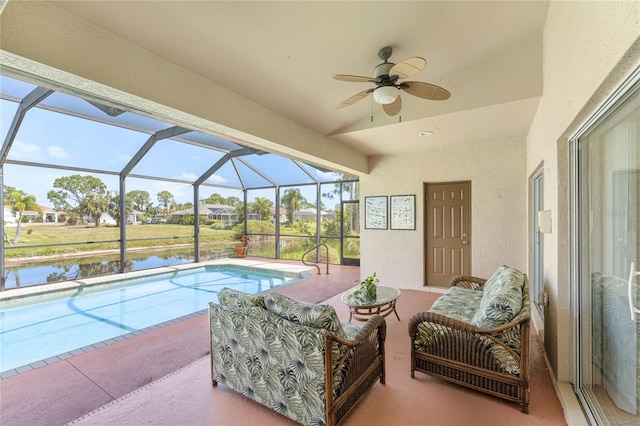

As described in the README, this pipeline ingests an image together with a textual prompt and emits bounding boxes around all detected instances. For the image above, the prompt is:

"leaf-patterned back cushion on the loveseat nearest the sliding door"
[471,265,524,328]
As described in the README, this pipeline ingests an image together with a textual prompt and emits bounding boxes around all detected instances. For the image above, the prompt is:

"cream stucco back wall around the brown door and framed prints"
[360,139,527,288]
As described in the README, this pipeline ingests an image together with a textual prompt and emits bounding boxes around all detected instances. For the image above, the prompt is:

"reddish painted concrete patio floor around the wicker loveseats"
[0,266,566,425]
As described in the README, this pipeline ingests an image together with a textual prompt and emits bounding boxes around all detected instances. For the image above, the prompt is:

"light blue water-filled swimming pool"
[0,265,303,372]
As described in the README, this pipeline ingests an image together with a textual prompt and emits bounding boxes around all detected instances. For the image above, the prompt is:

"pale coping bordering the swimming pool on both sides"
[0,258,312,380]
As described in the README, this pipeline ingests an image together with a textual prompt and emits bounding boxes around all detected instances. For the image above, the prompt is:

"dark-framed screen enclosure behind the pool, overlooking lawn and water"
[0,75,360,290]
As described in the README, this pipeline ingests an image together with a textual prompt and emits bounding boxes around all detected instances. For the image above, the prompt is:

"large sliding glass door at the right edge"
[571,77,640,425]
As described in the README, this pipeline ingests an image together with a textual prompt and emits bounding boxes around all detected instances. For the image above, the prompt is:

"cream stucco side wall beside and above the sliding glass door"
[526,2,640,382]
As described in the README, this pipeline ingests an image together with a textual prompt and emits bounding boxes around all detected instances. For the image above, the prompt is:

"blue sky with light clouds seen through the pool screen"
[0,84,350,208]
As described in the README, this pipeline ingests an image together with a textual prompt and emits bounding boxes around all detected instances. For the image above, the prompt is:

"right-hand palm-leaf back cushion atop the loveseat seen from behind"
[264,293,347,339]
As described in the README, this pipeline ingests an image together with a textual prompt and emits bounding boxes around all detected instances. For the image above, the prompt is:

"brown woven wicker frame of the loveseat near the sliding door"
[409,273,531,413]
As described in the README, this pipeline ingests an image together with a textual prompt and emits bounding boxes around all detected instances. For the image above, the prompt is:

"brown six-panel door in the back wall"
[424,181,471,287]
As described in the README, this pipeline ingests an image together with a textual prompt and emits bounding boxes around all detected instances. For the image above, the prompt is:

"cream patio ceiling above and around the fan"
[51,1,548,155]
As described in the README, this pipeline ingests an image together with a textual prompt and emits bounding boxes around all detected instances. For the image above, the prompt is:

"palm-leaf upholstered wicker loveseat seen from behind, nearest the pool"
[209,288,386,425]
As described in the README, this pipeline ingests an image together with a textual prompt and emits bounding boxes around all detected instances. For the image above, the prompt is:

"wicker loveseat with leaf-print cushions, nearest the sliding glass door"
[409,265,531,413]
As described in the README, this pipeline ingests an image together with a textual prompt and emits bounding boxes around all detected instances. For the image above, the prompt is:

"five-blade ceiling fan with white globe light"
[333,46,451,115]
